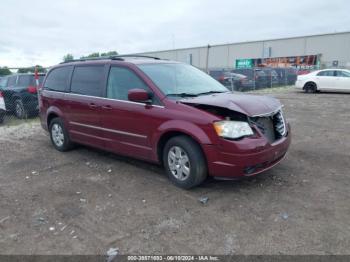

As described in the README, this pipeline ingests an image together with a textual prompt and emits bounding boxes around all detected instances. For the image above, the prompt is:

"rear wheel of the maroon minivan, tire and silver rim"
[49,117,73,152]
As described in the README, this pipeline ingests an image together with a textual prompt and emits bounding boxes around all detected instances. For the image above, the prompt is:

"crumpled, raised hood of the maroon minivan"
[180,93,282,117]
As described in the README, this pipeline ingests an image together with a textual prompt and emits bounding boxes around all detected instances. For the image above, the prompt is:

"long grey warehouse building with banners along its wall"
[136,32,350,70]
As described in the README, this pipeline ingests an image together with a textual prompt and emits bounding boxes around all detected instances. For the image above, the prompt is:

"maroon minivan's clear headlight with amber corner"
[213,120,254,139]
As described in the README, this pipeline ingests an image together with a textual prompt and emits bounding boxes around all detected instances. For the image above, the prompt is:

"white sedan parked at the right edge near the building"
[295,69,350,92]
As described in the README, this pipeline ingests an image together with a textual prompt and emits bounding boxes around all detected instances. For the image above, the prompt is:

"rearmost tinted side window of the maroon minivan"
[44,66,73,92]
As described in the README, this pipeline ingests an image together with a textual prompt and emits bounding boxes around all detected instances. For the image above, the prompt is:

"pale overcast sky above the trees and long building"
[0,0,350,67]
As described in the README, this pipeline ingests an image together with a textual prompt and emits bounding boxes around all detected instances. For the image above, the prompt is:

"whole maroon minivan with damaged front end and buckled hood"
[39,56,291,188]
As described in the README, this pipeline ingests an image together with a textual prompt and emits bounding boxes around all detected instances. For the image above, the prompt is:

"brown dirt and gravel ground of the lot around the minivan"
[0,89,350,254]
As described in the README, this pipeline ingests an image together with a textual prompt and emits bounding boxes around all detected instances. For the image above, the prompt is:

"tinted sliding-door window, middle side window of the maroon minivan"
[71,66,104,96]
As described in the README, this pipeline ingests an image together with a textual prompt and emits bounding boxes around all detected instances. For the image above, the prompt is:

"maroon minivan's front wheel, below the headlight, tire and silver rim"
[163,136,208,189]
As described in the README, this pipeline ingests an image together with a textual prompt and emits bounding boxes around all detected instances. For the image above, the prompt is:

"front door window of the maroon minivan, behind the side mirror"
[107,67,150,100]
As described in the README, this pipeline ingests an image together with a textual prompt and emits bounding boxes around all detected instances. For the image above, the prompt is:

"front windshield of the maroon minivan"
[138,63,228,97]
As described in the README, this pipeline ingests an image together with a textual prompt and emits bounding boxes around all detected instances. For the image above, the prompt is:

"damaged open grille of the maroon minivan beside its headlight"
[250,110,287,143]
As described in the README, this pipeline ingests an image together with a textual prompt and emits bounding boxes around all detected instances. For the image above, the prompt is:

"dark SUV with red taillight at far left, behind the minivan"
[1,74,45,119]
